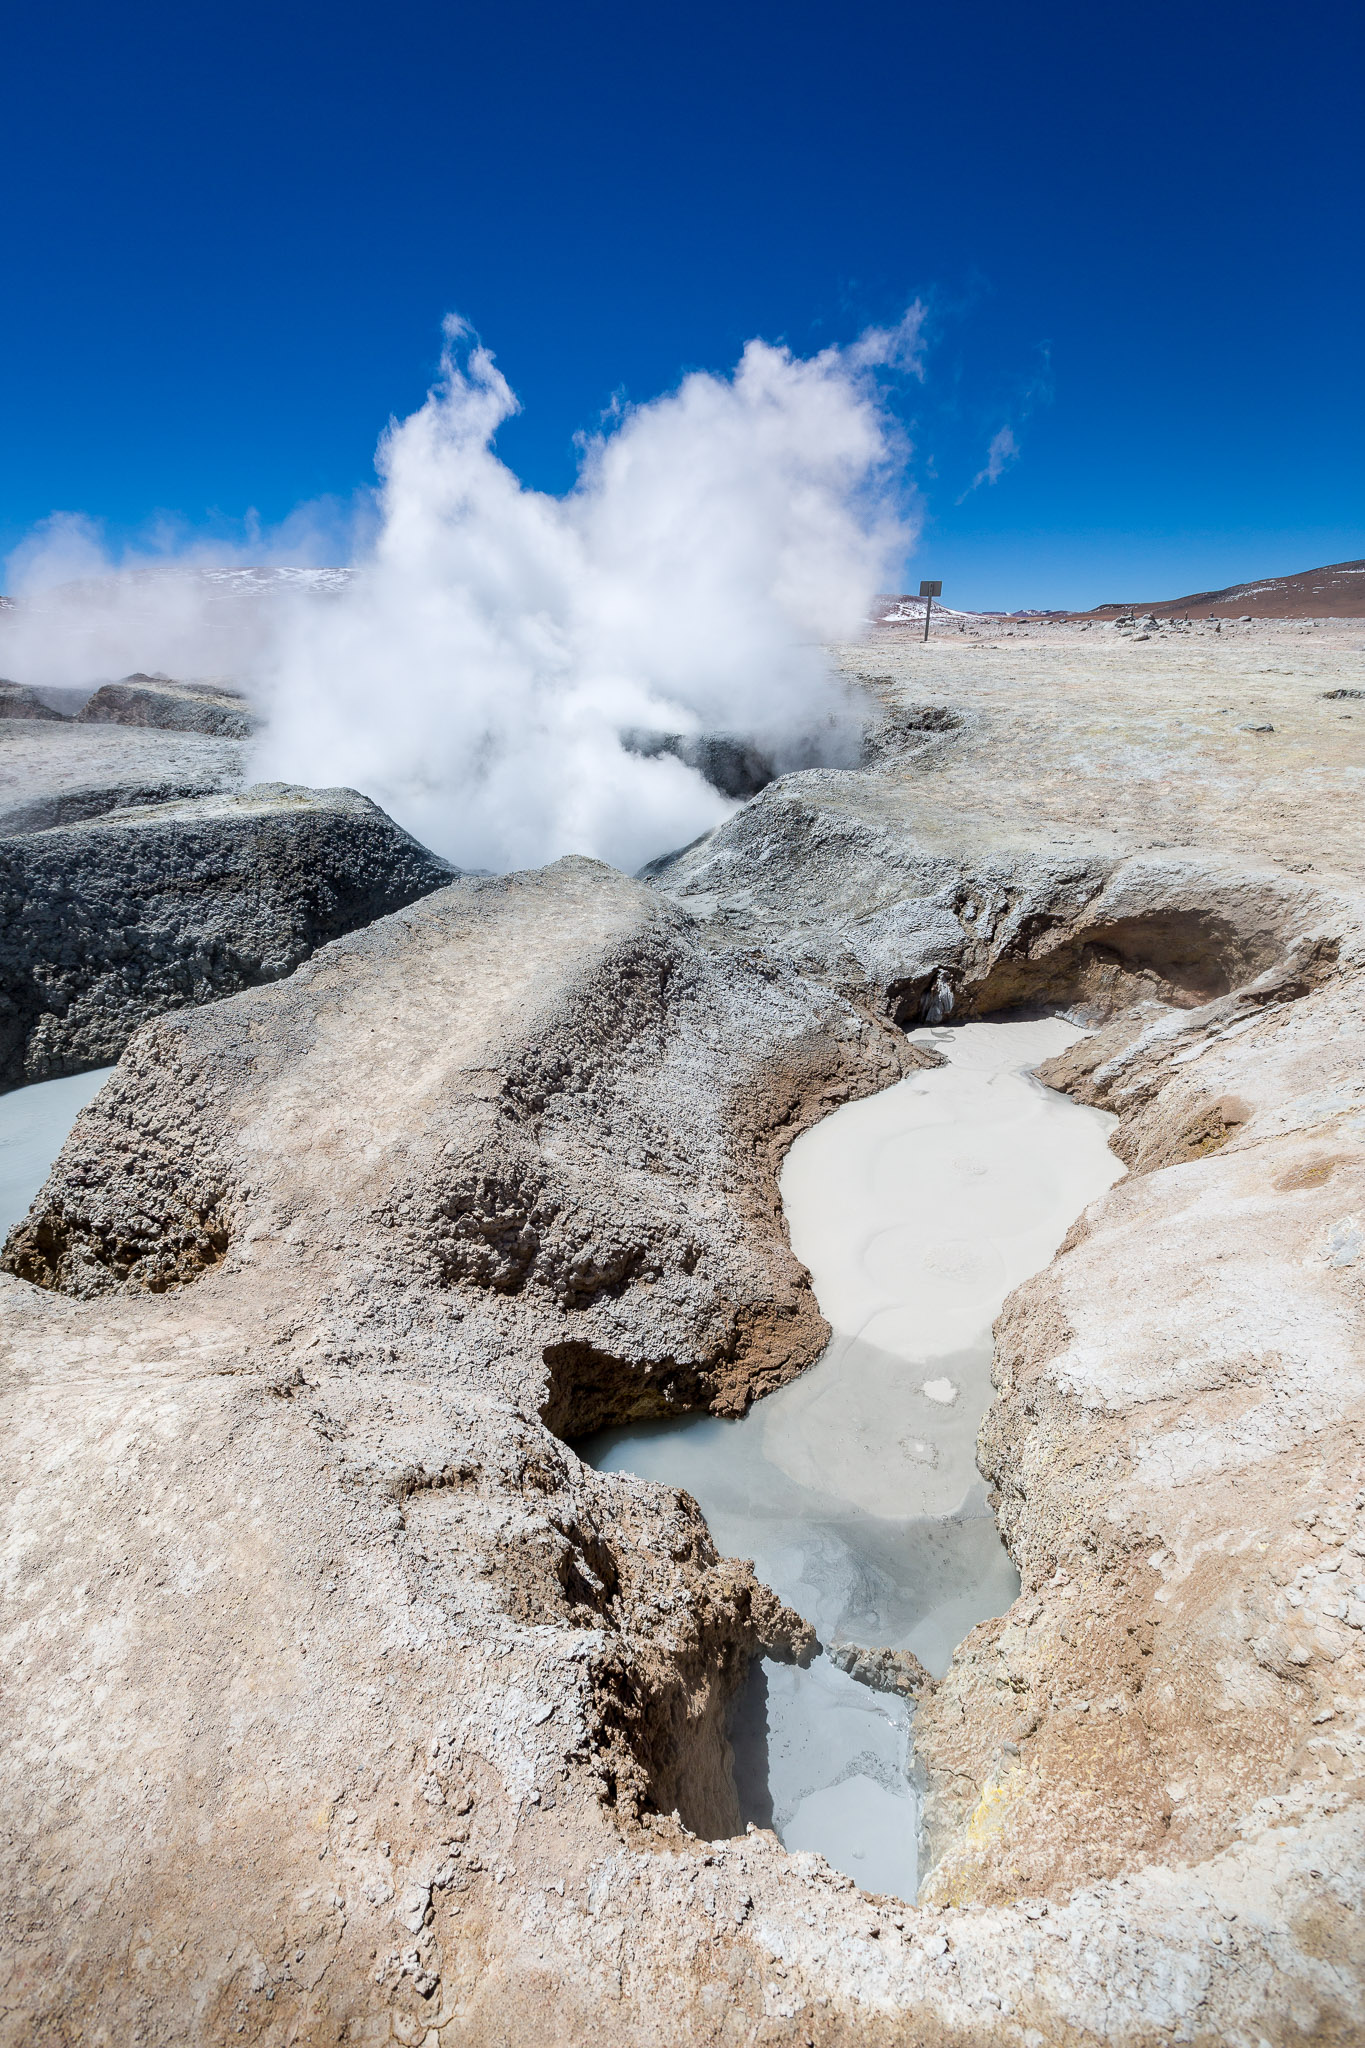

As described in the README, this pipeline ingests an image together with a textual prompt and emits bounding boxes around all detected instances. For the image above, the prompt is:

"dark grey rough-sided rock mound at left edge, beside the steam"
[0,784,452,1085]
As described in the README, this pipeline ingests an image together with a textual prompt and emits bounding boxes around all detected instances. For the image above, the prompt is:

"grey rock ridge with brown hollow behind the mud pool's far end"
[649,768,1345,1024]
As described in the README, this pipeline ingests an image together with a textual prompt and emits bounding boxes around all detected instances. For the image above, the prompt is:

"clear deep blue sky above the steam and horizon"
[0,0,1365,606]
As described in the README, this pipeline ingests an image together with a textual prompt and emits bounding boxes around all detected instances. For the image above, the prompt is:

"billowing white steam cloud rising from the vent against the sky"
[6,307,919,870]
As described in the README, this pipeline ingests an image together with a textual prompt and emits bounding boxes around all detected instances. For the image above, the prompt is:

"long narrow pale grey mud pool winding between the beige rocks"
[577,1018,1124,1896]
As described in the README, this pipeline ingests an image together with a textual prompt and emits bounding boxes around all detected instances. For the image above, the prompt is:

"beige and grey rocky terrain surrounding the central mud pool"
[0,629,1365,2048]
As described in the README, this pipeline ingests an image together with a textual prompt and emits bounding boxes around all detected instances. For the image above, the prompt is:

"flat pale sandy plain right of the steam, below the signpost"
[837,621,1365,883]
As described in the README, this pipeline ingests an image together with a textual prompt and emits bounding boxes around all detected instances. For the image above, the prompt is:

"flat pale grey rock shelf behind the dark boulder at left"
[0,717,248,836]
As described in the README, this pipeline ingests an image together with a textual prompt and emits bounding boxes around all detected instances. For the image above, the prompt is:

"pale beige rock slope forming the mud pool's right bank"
[919,965,1365,1898]
